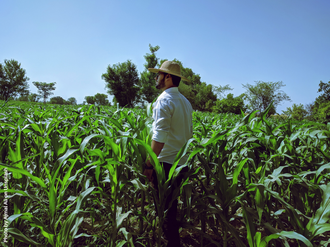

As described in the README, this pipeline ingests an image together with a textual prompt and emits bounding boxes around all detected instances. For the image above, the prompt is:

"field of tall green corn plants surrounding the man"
[0,101,330,247]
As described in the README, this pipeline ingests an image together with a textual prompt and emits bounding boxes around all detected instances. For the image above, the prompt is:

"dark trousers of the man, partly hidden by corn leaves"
[153,162,188,247]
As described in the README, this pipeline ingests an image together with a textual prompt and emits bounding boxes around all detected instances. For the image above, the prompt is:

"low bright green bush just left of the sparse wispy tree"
[213,93,246,114]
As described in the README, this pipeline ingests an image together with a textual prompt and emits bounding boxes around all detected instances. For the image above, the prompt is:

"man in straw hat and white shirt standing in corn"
[143,61,193,247]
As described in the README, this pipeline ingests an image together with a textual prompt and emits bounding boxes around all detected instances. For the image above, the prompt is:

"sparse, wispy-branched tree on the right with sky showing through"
[242,81,291,115]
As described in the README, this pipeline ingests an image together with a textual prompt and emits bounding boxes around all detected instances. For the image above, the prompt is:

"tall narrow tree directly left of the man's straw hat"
[139,44,159,103]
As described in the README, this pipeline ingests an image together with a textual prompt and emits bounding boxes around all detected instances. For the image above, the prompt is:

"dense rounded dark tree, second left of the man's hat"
[102,60,139,107]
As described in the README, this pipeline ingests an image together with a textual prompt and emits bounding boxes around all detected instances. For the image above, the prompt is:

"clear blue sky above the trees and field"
[0,0,330,113]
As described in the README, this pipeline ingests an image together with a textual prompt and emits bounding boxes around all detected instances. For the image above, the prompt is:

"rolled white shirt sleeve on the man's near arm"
[152,100,172,143]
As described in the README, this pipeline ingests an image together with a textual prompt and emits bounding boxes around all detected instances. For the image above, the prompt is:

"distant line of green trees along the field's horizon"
[0,45,330,121]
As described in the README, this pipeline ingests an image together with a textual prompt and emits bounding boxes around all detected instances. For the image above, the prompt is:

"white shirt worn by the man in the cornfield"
[152,87,193,164]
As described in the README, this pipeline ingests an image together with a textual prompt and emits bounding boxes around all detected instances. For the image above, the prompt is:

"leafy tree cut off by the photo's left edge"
[0,59,29,100]
